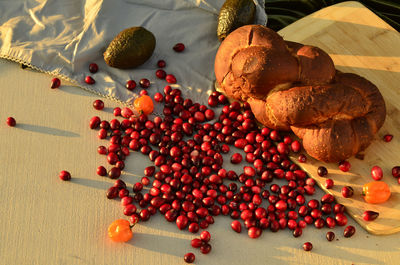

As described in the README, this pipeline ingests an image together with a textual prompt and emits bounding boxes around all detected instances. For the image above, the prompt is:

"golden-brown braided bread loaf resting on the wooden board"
[215,25,386,162]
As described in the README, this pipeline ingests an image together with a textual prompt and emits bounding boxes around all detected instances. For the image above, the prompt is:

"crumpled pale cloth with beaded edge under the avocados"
[0,0,267,109]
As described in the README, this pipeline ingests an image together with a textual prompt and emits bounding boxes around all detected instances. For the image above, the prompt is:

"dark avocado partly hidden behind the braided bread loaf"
[217,0,256,41]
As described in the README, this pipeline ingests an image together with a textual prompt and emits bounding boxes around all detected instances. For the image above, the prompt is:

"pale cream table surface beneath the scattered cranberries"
[0,12,400,265]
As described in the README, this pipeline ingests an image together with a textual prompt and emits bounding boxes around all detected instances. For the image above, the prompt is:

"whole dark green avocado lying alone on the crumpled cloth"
[103,27,156,69]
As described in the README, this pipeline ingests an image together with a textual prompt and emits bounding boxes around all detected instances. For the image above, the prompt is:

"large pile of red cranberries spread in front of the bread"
[89,66,362,260]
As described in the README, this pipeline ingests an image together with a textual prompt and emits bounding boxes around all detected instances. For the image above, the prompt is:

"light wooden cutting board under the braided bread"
[279,2,400,235]
